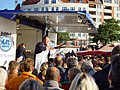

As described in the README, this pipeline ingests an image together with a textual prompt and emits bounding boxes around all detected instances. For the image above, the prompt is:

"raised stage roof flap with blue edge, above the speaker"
[0,10,97,33]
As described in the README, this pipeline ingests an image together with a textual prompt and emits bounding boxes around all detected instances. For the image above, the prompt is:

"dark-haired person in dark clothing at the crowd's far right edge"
[108,45,120,90]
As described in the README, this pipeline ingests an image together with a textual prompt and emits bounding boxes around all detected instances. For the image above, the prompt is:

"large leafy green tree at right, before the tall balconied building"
[92,18,120,45]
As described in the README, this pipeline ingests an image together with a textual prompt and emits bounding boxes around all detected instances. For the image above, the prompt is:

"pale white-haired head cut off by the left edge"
[0,68,8,87]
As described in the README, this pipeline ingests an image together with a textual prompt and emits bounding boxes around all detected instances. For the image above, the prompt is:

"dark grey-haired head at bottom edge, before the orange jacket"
[19,79,44,90]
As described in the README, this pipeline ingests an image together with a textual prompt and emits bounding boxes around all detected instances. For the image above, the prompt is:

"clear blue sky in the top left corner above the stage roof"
[0,0,22,10]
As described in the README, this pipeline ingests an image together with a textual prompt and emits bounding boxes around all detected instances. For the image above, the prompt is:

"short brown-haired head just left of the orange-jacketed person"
[8,61,19,74]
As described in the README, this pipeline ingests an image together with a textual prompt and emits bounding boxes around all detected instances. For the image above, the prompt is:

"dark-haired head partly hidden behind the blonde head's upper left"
[68,67,82,82]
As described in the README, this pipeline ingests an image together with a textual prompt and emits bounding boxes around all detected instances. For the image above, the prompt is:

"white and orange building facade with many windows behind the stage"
[21,0,120,45]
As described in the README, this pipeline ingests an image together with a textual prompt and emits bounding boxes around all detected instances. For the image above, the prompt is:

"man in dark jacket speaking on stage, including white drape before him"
[34,36,50,72]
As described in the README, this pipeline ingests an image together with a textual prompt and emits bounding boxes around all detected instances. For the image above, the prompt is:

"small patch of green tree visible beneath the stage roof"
[57,32,70,44]
